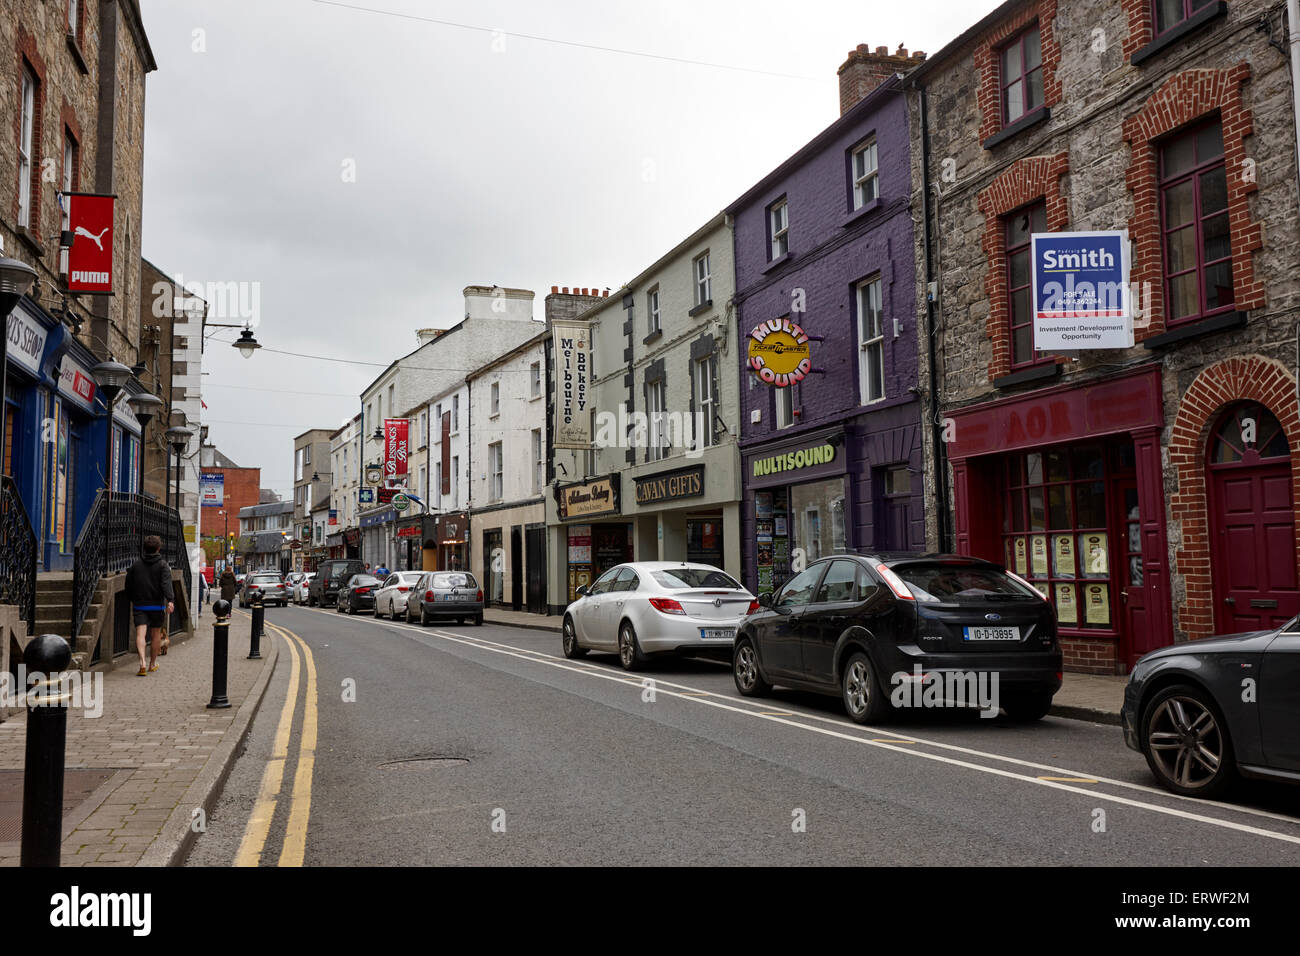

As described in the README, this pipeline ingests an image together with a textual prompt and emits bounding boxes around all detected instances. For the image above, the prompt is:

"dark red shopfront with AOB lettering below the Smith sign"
[948,365,1174,674]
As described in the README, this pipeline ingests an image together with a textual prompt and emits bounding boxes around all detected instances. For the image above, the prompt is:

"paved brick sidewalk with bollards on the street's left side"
[0,607,278,866]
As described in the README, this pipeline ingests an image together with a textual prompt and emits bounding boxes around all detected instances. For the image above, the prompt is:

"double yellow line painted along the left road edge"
[235,623,317,866]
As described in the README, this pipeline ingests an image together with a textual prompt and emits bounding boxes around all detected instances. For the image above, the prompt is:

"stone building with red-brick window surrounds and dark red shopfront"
[907,0,1300,672]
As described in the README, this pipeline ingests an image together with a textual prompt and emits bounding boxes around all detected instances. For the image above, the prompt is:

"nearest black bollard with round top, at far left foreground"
[22,633,73,866]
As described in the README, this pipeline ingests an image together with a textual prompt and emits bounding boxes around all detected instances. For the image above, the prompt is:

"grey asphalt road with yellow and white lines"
[180,607,1300,866]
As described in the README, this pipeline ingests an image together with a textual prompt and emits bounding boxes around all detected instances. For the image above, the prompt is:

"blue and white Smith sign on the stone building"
[1031,229,1134,351]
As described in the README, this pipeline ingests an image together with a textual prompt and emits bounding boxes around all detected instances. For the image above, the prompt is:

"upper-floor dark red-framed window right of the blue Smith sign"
[1160,120,1235,323]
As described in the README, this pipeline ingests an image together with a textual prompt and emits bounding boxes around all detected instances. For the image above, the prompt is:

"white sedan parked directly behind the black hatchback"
[562,561,758,671]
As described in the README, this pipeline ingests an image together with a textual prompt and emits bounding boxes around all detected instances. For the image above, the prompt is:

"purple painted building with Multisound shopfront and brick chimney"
[727,47,924,593]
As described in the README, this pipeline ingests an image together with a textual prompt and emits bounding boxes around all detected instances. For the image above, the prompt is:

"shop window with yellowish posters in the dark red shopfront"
[1002,442,1127,632]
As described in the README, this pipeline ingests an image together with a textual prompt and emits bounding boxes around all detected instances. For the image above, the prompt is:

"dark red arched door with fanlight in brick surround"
[1206,402,1300,633]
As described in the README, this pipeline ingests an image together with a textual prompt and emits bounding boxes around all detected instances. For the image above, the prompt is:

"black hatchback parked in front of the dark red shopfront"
[732,553,1062,723]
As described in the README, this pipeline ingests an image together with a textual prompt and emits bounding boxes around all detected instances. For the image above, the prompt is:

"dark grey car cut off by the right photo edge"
[1119,618,1300,797]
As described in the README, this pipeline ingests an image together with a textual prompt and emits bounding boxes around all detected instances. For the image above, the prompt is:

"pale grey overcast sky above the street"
[142,0,997,498]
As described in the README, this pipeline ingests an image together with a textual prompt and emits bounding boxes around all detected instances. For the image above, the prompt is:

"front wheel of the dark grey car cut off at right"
[1141,684,1236,797]
